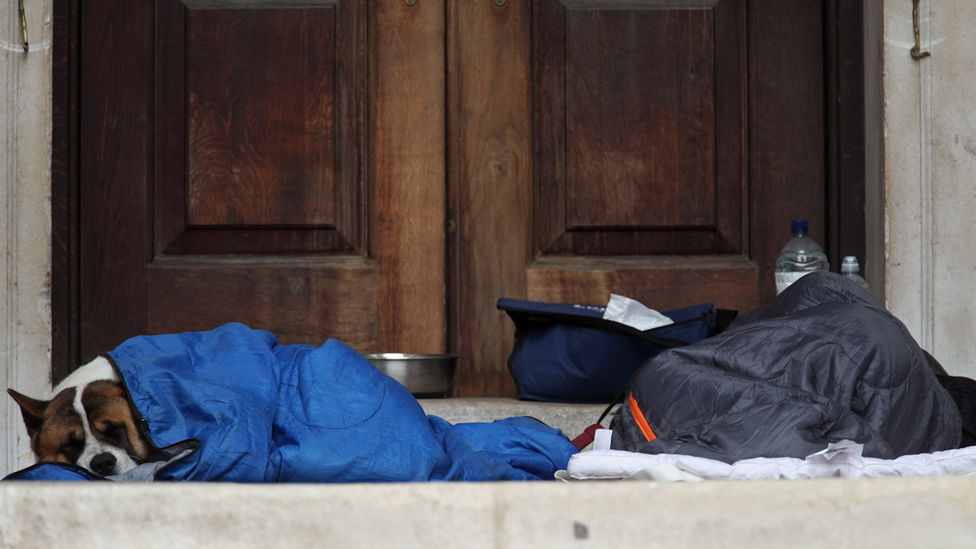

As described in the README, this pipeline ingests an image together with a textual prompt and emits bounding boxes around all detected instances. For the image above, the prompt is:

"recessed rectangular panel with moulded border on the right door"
[533,0,748,256]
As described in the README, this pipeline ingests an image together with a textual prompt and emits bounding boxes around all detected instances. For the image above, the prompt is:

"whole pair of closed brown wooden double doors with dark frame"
[53,0,860,396]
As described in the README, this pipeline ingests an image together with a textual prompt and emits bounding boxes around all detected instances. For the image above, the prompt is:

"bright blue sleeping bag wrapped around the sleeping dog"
[7,324,576,482]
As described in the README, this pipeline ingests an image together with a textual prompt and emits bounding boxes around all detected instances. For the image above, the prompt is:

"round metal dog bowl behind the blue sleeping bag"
[365,353,458,398]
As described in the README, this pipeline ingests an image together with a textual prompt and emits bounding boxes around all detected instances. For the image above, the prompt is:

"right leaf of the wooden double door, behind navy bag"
[449,0,825,395]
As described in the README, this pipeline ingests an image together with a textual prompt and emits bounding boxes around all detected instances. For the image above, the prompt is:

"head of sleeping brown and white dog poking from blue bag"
[7,357,159,477]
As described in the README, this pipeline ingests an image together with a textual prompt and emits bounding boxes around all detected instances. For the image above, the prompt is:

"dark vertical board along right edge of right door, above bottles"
[748,0,837,303]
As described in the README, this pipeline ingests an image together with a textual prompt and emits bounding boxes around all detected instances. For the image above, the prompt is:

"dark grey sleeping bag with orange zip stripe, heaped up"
[612,273,962,463]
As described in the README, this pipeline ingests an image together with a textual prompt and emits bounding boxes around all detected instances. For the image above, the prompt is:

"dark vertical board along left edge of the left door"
[78,2,153,362]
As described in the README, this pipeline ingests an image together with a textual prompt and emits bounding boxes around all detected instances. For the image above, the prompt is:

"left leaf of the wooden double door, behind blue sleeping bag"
[72,0,447,361]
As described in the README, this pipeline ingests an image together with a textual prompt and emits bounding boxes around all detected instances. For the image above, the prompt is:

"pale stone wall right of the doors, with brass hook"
[884,0,976,377]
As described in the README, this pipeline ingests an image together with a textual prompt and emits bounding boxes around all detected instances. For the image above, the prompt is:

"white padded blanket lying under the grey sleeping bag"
[556,428,976,482]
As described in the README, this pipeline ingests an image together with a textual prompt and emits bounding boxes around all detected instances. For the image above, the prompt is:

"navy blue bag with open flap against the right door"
[498,299,735,403]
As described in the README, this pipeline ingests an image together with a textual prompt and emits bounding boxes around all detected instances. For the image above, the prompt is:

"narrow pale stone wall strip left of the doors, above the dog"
[0,1,51,472]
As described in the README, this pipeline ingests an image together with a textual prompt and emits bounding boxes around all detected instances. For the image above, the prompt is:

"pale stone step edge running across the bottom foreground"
[0,477,976,549]
